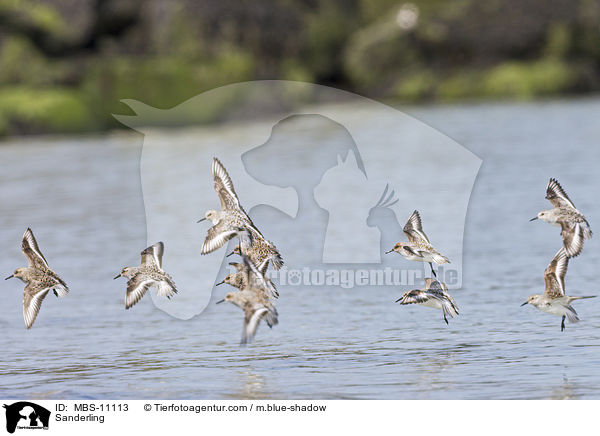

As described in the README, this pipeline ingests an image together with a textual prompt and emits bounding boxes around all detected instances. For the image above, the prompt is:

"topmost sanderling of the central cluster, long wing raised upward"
[198,157,283,269]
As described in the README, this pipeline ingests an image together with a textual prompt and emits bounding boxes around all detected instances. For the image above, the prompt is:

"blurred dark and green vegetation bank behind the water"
[0,0,600,135]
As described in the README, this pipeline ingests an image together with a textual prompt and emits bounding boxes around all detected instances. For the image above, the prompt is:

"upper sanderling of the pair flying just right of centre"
[385,210,450,277]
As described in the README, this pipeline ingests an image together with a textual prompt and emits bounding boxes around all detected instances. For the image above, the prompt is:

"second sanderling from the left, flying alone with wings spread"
[115,242,177,309]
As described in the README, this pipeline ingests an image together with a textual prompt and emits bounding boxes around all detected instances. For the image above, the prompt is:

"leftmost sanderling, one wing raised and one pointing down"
[6,228,69,329]
